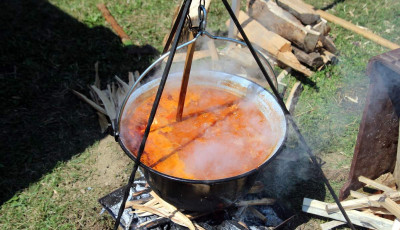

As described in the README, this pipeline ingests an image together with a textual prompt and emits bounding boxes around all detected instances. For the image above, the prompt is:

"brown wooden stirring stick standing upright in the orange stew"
[176,32,196,122]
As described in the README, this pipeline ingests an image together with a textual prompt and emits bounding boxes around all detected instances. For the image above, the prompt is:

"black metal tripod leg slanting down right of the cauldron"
[222,0,355,230]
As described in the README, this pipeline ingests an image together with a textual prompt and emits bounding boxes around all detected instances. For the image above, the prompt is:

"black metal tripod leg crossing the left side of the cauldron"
[114,0,192,230]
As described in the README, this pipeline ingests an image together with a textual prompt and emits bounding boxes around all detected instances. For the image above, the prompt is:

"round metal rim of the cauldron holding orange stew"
[117,71,288,184]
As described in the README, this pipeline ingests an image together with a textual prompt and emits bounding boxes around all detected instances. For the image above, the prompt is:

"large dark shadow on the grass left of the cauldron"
[0,0,157,205]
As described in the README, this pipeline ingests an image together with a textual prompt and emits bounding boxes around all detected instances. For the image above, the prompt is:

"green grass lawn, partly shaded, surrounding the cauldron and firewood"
[0,0,400,229]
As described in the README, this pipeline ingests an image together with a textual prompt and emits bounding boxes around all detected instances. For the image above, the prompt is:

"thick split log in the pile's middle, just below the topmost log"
[248,0,320,52]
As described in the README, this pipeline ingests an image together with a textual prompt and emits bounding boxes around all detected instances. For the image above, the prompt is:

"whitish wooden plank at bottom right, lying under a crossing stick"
[302,198,393,230]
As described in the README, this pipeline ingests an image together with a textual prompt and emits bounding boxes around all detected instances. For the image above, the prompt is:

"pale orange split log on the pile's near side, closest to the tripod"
[233,11,313,76]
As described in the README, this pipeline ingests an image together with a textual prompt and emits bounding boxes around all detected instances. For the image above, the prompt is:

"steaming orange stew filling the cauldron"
[121,85,278,180]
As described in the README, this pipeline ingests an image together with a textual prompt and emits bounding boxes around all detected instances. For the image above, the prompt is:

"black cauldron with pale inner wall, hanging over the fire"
[118,71,287,211]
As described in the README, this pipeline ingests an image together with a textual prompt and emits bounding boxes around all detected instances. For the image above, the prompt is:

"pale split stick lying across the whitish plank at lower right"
[326,192,400,212]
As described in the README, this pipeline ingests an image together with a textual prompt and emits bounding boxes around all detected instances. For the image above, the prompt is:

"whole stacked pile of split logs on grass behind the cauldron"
[230,0,337,76]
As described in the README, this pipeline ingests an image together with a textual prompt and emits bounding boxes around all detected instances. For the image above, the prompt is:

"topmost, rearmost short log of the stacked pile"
[277,0,320,25]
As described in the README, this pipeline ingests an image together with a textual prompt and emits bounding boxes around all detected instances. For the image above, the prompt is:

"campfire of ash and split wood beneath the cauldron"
[99,174,293,230]
